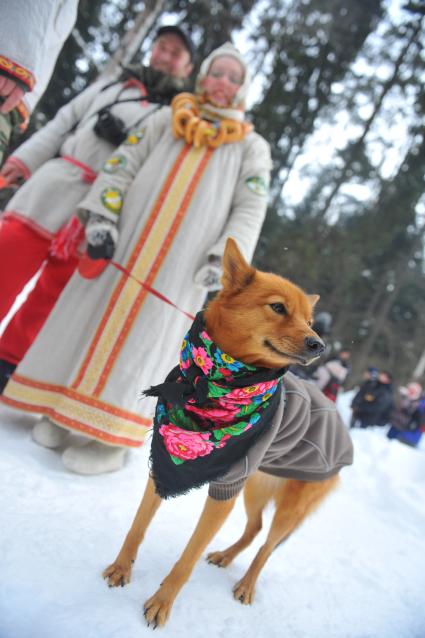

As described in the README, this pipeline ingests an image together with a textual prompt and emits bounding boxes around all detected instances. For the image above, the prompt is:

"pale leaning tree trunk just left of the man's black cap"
[101,0,167,76]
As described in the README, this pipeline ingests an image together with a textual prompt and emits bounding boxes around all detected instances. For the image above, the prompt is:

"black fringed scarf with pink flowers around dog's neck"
[144,312,286,498]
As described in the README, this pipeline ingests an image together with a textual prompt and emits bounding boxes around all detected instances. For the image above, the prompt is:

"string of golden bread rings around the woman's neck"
[171,93,254,148]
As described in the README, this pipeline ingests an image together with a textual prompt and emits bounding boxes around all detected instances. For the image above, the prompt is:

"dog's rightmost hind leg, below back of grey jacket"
[233,476,339,605]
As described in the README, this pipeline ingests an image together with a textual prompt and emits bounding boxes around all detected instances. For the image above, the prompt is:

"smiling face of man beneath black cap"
[149,33,193,78]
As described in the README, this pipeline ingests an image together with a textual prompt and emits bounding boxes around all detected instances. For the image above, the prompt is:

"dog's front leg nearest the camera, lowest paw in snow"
[144,496,236,628]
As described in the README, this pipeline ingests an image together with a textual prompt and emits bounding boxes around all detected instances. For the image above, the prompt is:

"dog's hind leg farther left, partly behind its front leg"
[207,472,282,567]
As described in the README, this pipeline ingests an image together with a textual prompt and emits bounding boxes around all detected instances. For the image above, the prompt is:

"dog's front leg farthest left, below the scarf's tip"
[103,477,161,587]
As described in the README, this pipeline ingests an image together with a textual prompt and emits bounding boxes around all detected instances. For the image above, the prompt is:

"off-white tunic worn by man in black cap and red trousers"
[5,80,162,236]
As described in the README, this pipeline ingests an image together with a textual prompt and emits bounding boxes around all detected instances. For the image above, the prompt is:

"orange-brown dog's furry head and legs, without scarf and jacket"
[103,239,351,627]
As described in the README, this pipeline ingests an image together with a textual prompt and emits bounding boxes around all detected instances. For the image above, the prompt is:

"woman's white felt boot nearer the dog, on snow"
[62,441,126,474]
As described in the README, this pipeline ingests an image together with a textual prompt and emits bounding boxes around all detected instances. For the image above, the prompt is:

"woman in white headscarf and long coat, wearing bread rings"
[2,43,271,474]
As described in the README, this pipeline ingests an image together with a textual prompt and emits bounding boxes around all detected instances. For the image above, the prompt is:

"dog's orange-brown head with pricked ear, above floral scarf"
[205,239,325,368]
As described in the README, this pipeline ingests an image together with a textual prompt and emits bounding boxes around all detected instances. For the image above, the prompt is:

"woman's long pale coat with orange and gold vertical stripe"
[3,107,271,447]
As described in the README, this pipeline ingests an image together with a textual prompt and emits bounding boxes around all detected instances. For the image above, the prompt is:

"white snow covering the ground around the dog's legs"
[0,393,425,638]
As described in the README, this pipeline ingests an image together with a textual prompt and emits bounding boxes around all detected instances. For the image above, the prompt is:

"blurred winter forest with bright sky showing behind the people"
[11,0,425,384]
